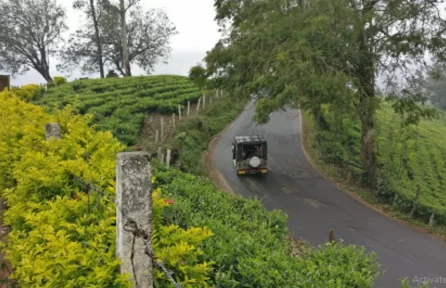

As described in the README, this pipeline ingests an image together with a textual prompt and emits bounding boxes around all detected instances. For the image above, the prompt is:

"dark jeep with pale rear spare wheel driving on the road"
[232,135,268,175]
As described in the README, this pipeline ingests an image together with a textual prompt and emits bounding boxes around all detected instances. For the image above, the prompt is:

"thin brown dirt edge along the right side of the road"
[298,109,446,242]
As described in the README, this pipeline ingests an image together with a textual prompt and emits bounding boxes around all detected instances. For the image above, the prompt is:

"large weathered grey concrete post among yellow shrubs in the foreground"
[116,152,153,288]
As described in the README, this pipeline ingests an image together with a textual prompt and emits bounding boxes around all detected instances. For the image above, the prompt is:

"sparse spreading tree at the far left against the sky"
[0,0,67,82]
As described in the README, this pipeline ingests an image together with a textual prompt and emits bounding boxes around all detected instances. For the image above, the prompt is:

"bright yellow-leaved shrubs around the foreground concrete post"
[0,91,212,287]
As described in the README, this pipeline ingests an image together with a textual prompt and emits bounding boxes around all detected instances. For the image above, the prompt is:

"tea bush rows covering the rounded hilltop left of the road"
[33,76,201,146]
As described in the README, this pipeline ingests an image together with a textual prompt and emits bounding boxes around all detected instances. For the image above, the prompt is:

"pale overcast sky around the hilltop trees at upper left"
[1,0,220,86]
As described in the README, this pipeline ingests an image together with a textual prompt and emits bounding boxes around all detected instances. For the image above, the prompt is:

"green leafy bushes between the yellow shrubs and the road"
[154,166,379,288]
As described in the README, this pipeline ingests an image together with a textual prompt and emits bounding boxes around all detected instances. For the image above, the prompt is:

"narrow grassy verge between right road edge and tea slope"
[302,112,446,241]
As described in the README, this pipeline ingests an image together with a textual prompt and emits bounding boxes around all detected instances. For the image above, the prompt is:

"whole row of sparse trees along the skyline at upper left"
[0,0,177,82]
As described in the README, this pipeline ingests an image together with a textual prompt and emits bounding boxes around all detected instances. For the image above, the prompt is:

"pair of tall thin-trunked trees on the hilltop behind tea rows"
[60,0,177,76]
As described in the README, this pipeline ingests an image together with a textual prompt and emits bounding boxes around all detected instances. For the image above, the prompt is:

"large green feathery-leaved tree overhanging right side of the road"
[206,0,445,186]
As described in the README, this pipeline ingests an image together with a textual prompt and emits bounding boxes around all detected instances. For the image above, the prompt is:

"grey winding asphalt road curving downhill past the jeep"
[212,102,446,288]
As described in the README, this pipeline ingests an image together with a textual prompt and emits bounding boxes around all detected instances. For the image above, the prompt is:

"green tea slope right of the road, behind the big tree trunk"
[305,101,446,232]
